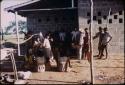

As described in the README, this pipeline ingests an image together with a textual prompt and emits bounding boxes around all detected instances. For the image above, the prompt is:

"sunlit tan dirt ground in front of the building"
[27,56,125,84]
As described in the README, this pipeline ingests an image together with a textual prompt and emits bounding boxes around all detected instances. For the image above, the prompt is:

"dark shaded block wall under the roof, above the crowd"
[27,9,78,34]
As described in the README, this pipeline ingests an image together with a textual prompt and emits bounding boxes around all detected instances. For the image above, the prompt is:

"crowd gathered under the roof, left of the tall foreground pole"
[25,28,89,66]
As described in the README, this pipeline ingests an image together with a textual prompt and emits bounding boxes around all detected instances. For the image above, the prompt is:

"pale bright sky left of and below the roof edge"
[1,0,29,29]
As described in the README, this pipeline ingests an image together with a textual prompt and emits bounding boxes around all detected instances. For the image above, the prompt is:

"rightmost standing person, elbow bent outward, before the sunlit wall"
[99,27,112,59]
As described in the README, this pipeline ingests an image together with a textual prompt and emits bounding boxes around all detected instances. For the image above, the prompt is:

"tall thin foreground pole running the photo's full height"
[90,0,95,84]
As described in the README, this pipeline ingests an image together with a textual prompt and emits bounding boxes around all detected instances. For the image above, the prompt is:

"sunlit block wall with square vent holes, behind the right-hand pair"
[78,0,124,55]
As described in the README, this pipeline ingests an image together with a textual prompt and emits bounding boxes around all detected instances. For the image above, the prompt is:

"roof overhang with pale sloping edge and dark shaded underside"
[5,0,77,16]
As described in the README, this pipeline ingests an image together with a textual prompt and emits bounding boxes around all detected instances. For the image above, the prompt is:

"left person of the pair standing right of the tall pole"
[93,27,104,56]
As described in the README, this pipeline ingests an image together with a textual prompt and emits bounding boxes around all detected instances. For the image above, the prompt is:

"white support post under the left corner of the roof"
[15,11,20,56]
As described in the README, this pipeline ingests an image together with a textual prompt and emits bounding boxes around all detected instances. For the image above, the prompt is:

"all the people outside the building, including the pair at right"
[25,27,112,69]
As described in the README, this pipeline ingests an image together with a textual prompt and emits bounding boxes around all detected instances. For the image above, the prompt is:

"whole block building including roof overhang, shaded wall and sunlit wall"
[6,0,124,55]
